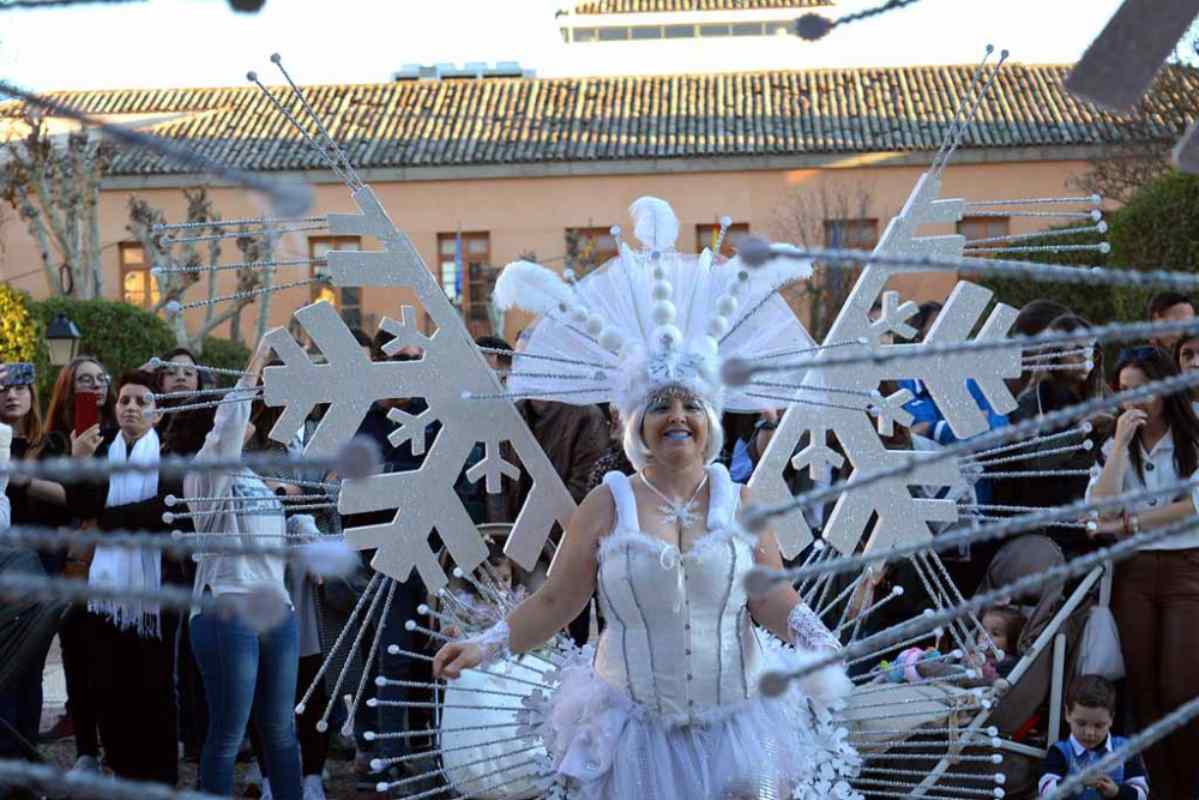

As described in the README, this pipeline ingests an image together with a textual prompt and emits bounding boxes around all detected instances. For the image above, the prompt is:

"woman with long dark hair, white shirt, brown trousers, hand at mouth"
[1087,347,1199,800]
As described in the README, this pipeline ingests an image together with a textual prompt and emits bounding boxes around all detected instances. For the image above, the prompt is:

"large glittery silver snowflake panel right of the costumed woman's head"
[749,170,1020,558]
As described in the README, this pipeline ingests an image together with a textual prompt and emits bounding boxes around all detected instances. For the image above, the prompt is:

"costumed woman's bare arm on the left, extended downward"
[433,486,616,678]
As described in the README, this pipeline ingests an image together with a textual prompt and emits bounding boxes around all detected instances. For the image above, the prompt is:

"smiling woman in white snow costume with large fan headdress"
[434,198,858,800]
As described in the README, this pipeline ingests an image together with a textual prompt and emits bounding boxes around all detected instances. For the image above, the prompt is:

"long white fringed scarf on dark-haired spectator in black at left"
[88,428,162,638]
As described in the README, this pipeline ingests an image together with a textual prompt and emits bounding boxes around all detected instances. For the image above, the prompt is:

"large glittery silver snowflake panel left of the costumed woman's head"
[264,187,574,591]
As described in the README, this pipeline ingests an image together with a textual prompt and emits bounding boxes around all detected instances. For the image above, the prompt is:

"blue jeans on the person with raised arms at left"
[191,613,302,800]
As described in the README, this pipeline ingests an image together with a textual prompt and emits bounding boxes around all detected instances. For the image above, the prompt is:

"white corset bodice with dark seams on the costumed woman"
[595,464,764,723]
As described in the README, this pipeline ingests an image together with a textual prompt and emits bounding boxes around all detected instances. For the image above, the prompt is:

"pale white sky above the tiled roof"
[0,0,1141,91]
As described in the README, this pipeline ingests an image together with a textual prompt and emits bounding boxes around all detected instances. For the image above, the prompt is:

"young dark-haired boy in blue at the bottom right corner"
[1037,675,1149,800]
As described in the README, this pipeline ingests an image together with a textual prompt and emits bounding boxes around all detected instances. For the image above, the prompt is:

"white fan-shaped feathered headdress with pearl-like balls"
[494,197,814,414]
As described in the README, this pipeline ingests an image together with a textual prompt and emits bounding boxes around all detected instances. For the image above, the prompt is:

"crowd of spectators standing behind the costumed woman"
[0,294,1199,800]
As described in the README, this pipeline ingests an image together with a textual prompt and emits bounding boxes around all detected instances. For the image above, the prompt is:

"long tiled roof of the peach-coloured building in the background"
[7,65,1199,175]
